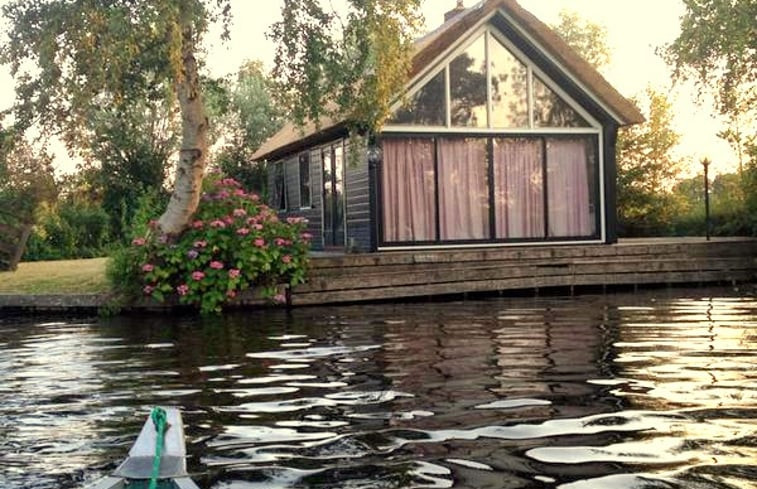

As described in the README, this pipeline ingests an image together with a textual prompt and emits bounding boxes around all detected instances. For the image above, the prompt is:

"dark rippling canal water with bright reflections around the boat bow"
[0,289,757,489]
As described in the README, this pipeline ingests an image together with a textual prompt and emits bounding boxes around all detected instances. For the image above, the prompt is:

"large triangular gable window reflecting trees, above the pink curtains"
[388,30,591,129]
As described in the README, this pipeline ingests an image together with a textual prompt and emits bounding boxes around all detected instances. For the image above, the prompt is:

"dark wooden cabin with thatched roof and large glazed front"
[255,0,644,252]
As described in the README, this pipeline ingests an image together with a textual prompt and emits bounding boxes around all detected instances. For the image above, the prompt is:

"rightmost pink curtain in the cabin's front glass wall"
[547,139,595,237]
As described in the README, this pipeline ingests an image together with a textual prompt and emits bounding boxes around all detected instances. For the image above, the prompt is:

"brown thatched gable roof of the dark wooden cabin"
[253,0,644,160]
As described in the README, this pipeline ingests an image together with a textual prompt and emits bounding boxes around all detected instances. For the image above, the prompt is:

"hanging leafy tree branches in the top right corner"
[664,0,757,114]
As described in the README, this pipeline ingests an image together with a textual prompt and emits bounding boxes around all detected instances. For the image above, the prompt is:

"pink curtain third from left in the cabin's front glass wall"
[494,139,544,239]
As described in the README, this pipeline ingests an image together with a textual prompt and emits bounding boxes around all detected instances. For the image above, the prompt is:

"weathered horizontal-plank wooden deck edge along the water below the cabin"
[291,238,757,306]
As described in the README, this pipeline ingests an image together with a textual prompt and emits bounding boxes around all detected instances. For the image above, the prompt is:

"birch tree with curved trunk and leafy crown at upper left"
[0,0,229,235]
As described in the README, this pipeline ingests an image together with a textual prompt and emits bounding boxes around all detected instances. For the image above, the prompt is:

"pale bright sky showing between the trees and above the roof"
[0,0,736,175]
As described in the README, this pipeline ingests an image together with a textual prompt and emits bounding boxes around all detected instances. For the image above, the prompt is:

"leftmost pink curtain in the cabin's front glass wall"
[382,139,436,243]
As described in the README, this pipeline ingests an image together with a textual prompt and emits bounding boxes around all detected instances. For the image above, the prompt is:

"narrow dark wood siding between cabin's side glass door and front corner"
[345,138,371,252]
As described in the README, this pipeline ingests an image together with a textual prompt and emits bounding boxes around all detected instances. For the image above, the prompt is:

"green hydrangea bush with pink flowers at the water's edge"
[108,175,310,314]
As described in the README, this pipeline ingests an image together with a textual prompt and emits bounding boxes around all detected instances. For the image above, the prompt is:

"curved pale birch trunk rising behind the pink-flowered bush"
[158,22,208,236]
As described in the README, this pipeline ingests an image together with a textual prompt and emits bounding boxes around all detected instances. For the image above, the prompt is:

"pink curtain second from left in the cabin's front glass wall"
[439,138,491,240]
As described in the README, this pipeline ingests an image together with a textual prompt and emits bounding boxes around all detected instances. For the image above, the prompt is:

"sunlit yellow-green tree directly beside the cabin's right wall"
[617,89,681,236]
